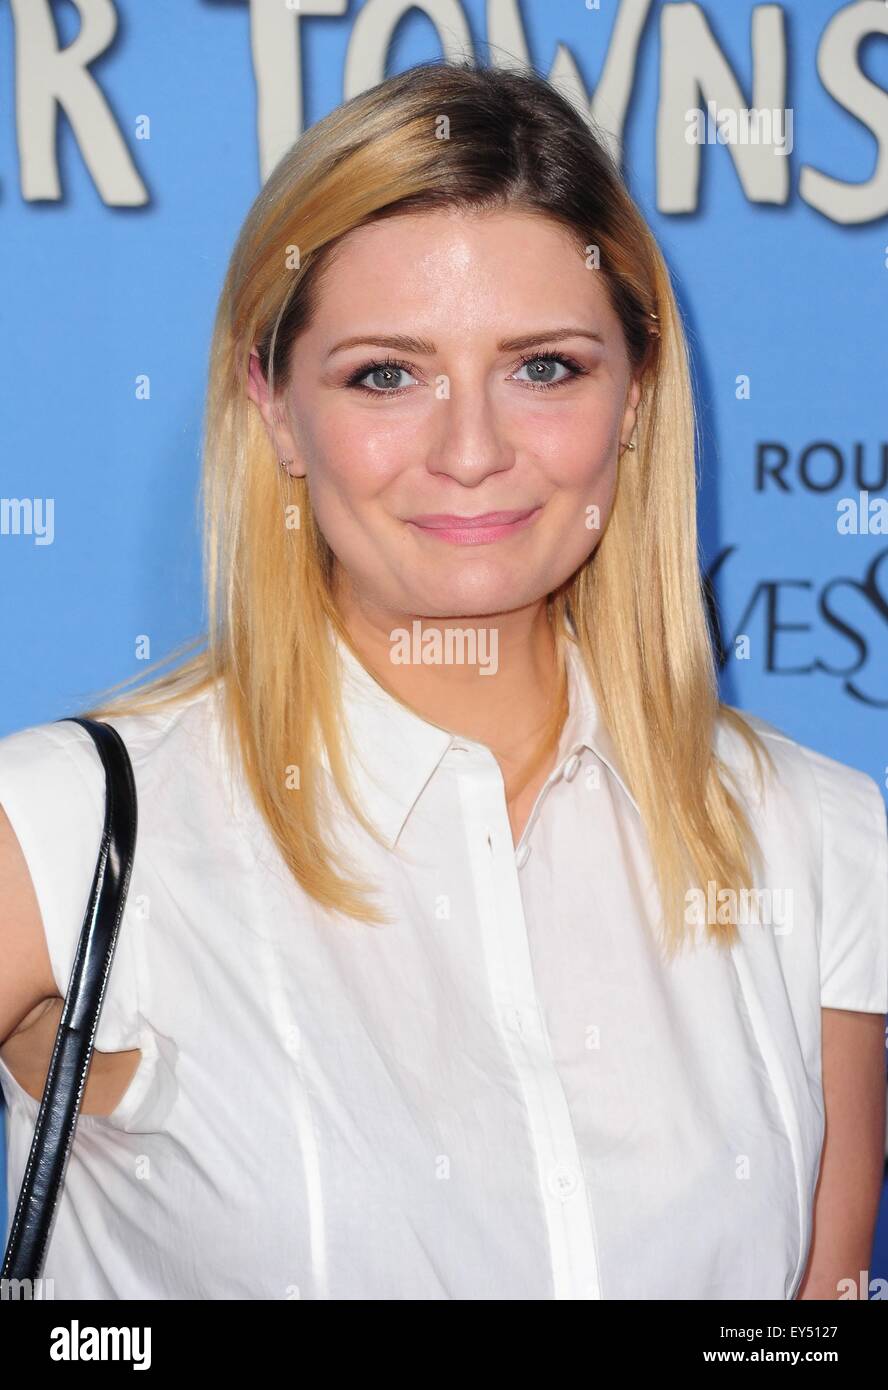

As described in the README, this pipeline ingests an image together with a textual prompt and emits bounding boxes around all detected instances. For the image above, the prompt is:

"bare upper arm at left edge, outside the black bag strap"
[0,805,58,1043]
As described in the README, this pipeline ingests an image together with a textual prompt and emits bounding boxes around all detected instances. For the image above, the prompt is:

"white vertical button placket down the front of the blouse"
[457,749,600,1300]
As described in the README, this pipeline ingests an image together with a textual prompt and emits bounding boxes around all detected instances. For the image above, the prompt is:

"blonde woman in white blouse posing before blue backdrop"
[0,64,888,1300]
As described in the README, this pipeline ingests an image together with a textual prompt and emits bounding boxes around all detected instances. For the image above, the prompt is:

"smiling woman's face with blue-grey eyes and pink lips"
[249,211,639,619]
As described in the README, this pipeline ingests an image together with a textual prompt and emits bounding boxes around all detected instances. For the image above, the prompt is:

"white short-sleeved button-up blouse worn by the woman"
[0,636,888,1300]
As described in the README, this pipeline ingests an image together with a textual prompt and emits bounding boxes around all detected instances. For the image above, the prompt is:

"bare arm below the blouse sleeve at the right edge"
[796,1009,885,1298]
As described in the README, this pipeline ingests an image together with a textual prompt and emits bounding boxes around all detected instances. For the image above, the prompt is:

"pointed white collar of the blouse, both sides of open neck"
[322,628,638,848]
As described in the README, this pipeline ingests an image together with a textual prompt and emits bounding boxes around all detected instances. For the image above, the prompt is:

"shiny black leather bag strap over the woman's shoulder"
[3,716,136,1280]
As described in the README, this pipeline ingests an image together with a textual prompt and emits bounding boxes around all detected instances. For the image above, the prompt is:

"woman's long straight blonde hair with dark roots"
[85,63,767,951]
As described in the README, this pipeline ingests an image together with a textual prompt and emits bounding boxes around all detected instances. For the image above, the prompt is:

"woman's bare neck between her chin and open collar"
[330,594,567,801]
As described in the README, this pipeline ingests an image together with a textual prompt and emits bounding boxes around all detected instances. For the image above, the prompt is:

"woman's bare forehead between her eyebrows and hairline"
[308,209,618,334]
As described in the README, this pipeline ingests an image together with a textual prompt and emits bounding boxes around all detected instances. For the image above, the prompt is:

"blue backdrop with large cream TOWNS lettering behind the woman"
[0,0,888,1277]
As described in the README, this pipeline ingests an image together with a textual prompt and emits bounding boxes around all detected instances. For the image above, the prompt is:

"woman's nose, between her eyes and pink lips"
[425,374,516,488]
